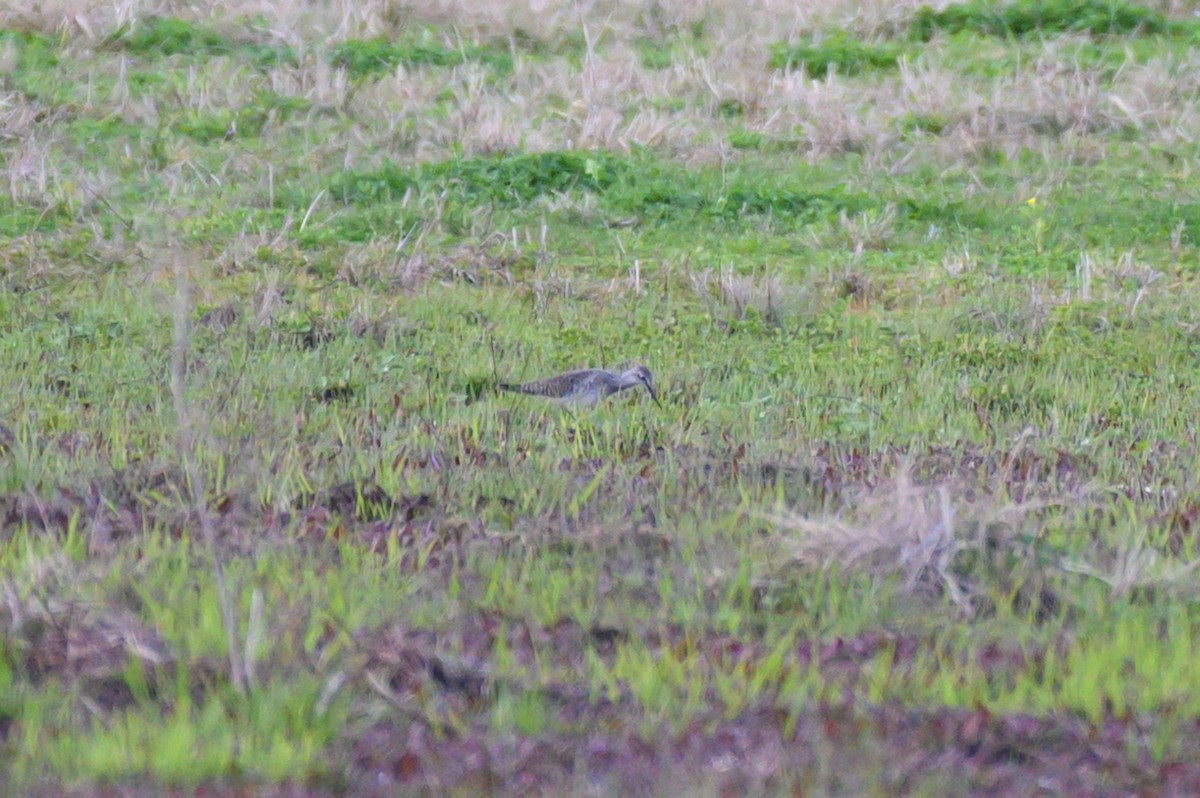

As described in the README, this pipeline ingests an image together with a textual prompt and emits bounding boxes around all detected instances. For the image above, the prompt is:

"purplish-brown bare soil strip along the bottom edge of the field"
[343,696,1200,797]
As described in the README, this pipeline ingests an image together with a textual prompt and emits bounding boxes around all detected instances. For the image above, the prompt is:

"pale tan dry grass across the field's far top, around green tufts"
[0,1,1200,168]
